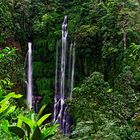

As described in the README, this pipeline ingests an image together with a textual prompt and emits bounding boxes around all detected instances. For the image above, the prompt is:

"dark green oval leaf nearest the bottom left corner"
[9,126,25,139]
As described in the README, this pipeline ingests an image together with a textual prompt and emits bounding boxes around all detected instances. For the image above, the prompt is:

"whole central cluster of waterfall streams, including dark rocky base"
[53,16,76,135]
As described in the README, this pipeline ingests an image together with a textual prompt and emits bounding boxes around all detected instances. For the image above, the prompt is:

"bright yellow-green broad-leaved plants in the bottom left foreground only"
[0,92,58,140]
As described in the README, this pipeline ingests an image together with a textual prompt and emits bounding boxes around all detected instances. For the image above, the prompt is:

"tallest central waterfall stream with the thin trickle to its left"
[54,16,68,123]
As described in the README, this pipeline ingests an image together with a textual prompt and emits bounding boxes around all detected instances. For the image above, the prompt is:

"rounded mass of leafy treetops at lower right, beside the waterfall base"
[71,69,140,139]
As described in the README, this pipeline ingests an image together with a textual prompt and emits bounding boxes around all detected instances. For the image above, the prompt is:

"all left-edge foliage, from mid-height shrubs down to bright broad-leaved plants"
[0,47,58,140]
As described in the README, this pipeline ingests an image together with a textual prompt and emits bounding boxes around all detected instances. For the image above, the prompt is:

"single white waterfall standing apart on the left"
[27,42,33,109]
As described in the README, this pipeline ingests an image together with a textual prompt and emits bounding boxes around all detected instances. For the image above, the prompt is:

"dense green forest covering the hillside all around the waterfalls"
[0,0,140,140]
